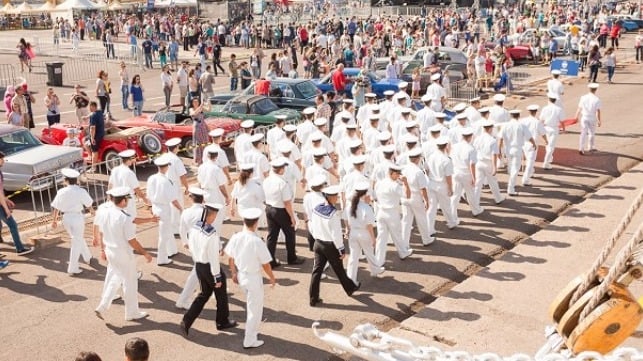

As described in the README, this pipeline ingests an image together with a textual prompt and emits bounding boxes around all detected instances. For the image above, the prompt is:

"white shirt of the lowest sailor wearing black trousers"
[188,222,221,276]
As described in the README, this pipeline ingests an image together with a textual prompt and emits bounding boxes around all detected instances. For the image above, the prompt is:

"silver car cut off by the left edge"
[0,124,83,191]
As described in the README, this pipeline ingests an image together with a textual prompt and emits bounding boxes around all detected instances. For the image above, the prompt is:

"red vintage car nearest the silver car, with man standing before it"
[40,124,164,170]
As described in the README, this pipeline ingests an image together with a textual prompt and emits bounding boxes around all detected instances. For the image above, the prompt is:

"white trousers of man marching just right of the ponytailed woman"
[375,205,411,265]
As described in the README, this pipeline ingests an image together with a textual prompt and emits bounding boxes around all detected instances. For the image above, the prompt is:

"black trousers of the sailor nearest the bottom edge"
[183,263,230,329]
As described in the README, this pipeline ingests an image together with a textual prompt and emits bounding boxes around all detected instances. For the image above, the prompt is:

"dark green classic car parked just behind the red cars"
[206,95,301,125]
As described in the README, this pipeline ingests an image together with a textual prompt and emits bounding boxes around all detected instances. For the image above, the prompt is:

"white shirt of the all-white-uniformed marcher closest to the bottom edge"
[224,229,272,275]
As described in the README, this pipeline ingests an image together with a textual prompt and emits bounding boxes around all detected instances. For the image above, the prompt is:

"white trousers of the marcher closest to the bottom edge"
[237,272,263,346]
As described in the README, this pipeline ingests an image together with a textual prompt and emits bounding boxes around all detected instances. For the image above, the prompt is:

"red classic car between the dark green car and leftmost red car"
[112,106,241,158]
